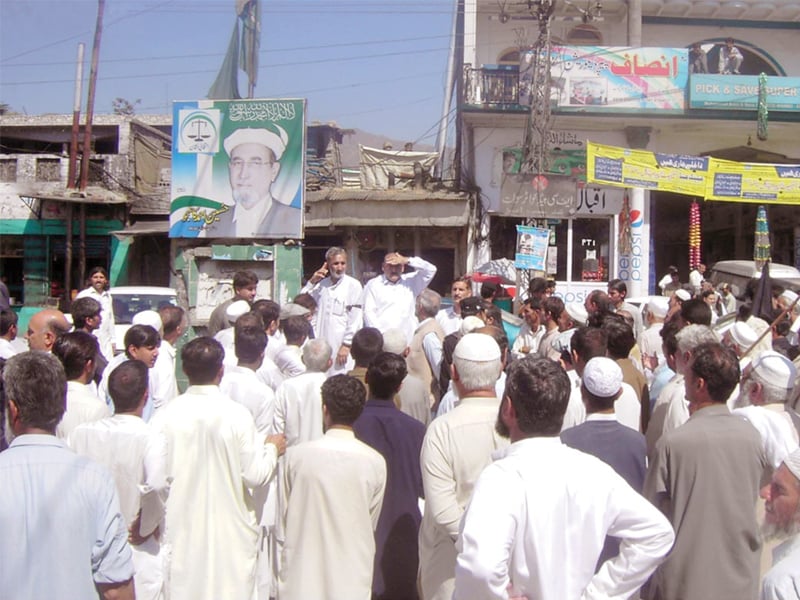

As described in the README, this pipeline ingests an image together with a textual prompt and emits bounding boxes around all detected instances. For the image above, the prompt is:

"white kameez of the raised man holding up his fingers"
[301,275,364,374]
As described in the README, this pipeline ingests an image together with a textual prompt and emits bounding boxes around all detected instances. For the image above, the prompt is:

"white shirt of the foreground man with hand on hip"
[453,438,675,600]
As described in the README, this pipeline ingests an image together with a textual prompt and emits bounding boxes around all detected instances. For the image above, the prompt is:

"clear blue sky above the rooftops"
[0,0,454,144]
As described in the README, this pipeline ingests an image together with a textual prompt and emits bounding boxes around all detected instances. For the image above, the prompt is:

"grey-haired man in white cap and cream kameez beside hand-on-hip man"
[419,333,508,600]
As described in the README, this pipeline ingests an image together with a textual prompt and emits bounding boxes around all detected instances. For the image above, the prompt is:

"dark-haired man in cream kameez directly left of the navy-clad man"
[278,375,386,600]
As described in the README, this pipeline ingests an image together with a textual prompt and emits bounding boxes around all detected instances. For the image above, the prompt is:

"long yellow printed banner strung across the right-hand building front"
[586,142,800,204]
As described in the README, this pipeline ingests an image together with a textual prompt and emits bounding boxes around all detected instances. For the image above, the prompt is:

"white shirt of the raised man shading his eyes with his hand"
[362,256,436,344]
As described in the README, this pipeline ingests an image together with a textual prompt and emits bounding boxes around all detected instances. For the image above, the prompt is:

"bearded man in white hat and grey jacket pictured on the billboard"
[207,125,301,237]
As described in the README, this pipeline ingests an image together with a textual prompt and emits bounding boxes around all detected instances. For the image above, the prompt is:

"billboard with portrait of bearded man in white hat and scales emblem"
[169,99,305,239]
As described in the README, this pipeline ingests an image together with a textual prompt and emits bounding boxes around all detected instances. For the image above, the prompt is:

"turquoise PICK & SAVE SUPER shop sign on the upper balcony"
[689,74,800,112]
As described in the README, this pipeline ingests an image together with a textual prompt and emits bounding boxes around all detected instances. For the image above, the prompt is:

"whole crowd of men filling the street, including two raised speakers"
[0,247,800,600]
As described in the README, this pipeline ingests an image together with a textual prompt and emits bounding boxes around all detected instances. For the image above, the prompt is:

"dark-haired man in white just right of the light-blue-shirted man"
[68,360,169,600]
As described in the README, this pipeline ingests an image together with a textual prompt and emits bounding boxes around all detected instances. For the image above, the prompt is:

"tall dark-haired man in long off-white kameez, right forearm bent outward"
[153,337,285,600]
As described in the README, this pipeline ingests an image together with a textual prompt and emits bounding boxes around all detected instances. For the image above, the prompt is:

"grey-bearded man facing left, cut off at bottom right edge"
[761,450,800,600]
